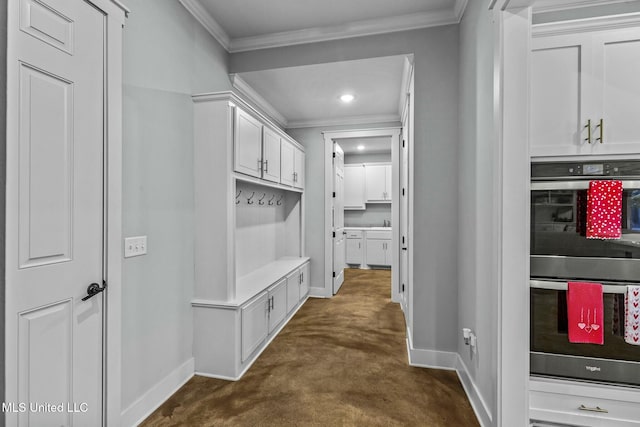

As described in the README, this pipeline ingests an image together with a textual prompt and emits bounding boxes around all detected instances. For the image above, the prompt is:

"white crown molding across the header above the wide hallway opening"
[229,9,464,53]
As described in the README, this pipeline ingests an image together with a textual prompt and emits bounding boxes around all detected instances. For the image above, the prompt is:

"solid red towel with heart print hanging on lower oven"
[567,282,604,345]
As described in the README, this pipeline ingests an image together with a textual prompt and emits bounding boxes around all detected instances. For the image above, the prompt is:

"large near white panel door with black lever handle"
[5,0,106,426]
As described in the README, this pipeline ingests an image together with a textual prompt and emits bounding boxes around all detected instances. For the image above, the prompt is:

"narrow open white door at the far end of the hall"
[332,143,346,295]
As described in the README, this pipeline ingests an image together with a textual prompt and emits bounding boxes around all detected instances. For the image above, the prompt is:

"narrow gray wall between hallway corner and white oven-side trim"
[456,2,498,420]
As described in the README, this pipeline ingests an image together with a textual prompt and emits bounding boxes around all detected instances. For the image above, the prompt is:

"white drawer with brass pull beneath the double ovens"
[529,390,640,427]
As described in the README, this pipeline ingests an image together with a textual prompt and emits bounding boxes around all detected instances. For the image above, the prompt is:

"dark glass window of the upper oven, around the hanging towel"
[531,190,640,258]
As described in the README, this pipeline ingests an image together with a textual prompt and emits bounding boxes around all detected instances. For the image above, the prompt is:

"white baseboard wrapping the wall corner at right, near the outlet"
[407,334,492,427]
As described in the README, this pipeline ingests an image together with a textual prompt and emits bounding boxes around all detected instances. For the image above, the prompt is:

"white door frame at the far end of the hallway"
[321,126,402,302]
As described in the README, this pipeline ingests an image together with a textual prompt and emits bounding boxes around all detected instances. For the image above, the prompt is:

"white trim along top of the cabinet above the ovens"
[532,13,640,37]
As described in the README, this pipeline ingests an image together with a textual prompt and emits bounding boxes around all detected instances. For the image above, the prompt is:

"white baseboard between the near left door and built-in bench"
[120,357,195,426]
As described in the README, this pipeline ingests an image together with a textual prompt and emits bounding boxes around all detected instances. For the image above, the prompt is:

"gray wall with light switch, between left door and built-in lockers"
[122,0,230,410]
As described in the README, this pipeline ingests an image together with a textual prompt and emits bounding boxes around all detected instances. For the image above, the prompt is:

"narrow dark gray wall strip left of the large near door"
[0,2,7,427]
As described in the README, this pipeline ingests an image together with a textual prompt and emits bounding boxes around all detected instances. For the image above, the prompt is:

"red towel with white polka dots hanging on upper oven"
[587,181,622,239]
